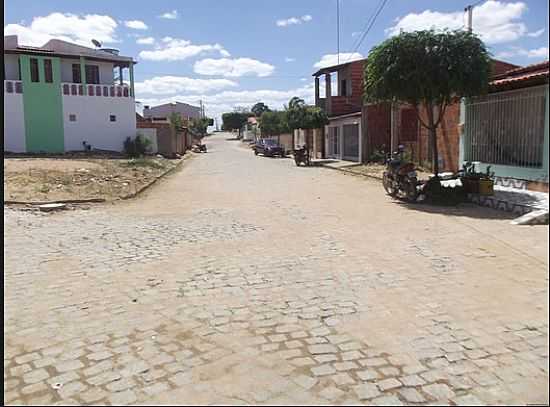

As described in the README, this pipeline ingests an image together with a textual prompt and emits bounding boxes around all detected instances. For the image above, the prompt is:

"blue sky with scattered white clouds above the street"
[4,0,548,121]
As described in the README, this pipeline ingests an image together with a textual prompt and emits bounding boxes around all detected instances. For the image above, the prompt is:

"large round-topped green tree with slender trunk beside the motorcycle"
[365,30,491,176]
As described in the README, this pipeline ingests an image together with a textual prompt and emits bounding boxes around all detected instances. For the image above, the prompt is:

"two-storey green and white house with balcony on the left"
[3,35,136,153]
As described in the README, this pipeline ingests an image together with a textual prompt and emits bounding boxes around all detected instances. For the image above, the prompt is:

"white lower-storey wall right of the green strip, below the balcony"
[63,95,136,151]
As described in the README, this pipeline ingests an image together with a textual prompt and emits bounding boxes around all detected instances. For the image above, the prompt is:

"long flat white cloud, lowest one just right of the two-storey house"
[135,76,237,95]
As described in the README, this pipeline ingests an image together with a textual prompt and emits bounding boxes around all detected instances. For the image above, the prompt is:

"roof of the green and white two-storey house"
[4,35,137,64]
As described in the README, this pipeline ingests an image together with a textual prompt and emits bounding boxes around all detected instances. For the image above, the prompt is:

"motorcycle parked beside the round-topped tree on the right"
[382,145,418,202]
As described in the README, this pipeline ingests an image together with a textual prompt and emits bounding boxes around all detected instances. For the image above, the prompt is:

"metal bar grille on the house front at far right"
[464,86,546,168]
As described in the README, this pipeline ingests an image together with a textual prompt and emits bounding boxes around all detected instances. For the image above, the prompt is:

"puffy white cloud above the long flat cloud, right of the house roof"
[139,37,229,61]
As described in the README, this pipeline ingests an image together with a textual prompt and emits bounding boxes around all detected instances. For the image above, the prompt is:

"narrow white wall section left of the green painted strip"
[4,92,26,153]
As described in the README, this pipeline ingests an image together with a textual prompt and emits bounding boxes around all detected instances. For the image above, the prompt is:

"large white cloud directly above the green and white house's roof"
[4,13,117,47]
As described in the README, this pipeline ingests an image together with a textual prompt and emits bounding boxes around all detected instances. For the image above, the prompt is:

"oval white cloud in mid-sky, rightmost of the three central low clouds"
[194,58,275,78]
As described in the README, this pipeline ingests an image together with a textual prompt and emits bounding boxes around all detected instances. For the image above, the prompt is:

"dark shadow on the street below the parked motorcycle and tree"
[393,199,520,220]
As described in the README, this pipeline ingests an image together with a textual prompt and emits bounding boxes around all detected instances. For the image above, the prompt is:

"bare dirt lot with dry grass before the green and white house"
[4,157,180,202]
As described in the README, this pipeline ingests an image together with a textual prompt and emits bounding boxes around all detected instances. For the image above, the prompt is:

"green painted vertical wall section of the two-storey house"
[20,55,65,153]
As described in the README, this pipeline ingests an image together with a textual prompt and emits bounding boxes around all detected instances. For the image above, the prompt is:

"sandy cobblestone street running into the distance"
[4,135,548,405]
